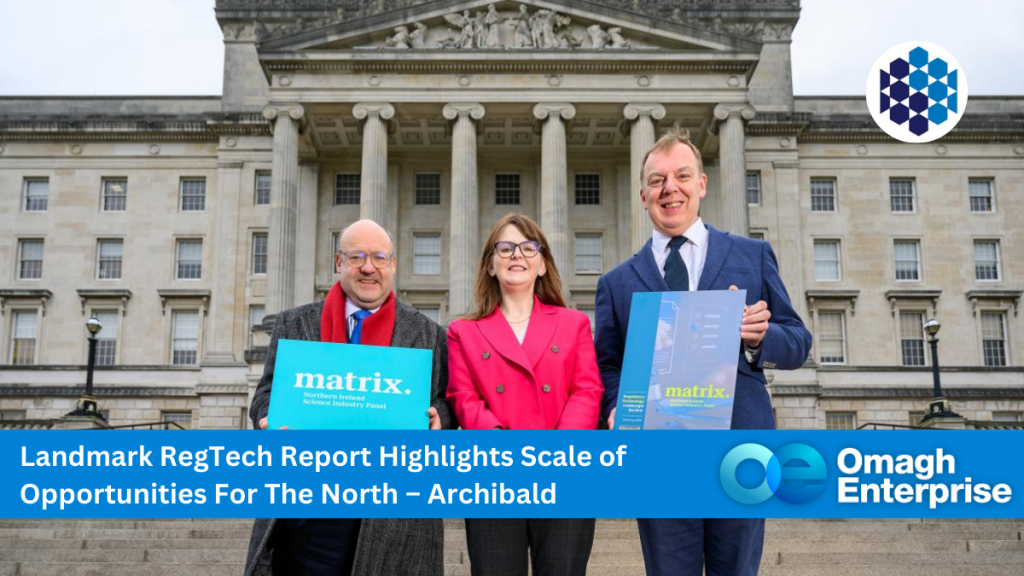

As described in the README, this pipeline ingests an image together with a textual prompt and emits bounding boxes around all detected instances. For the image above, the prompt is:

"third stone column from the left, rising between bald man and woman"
[442,104,484,319]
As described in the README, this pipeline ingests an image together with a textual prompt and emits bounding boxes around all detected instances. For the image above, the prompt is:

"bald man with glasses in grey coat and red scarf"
[245,220,456,576]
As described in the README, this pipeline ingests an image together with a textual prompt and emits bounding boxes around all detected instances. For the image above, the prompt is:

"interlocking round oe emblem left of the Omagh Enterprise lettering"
[719,444,828,504]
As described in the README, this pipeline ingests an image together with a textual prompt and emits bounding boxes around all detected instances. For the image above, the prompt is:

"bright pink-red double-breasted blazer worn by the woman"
[447,296,604,429]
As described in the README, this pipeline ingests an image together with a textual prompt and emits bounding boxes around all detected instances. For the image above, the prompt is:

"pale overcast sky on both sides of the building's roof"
[0,0,1024,95]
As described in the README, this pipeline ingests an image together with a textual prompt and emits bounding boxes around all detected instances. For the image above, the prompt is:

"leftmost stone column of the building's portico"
[263,105,305,317]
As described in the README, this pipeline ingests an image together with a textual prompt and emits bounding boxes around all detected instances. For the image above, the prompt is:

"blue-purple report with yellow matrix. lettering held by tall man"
[615,290,746,430]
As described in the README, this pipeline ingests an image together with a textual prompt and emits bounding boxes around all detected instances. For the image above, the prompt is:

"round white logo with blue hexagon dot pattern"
[866,42,968,143]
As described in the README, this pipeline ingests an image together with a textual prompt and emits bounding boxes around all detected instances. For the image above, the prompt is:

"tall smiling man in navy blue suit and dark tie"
[596,128,811,576]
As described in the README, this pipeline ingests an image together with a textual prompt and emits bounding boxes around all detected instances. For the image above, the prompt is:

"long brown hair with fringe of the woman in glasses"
[464,213,565,320]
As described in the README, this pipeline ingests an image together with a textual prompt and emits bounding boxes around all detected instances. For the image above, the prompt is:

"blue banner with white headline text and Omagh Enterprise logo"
[0,430,1024,519]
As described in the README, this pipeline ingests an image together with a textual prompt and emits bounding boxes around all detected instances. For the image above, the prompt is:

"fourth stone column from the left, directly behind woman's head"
[534,102,575,296]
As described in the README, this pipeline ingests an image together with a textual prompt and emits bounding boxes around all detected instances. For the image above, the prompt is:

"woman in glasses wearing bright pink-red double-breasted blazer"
[447,214,604,576]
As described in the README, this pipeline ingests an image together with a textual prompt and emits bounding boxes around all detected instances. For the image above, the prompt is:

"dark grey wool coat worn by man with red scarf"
[245,299,456,576]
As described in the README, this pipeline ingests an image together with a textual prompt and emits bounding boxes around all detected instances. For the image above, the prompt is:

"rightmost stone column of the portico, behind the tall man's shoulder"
[715,105,754,236]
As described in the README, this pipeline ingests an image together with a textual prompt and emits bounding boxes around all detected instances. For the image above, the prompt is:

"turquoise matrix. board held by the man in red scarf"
[267,340,433,430]
